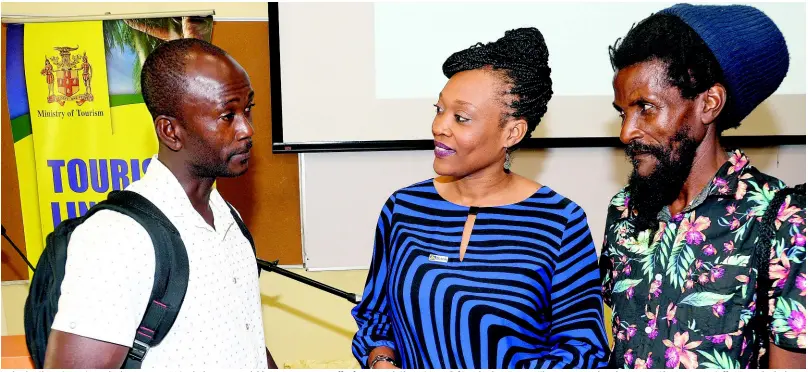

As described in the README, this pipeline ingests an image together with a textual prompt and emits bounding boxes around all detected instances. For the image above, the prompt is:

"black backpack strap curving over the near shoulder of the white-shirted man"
[94,191,189,369]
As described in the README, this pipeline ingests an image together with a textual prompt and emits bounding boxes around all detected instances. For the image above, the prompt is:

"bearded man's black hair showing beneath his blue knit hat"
[609,13,741,133]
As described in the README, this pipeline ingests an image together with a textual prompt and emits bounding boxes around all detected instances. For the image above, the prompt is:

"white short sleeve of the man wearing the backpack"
[51,210,155,347]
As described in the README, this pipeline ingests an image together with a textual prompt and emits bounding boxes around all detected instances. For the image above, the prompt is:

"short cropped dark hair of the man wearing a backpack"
[140,38,227,119]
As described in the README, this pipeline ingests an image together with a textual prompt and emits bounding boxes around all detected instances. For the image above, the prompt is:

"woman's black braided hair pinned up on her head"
[443,27,553,151]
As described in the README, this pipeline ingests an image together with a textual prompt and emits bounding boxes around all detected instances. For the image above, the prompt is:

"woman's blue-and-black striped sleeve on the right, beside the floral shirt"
[537,205,609,369]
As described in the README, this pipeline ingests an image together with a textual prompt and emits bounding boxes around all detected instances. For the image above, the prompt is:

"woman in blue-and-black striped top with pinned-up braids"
[352,28,608,369]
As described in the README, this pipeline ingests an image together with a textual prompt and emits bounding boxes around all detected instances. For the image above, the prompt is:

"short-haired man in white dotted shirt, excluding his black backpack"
[45,39,277,369]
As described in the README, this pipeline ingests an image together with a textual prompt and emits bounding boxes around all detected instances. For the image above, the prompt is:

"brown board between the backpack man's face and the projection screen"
[213,22,303,265]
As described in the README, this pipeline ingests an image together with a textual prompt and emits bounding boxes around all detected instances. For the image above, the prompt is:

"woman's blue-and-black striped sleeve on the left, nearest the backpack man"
[351,196,396,368]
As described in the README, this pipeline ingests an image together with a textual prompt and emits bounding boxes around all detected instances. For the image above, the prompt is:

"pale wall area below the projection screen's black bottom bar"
[300,145,806,270]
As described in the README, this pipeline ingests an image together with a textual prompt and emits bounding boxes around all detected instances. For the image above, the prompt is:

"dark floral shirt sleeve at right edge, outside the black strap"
[769,190,806,350]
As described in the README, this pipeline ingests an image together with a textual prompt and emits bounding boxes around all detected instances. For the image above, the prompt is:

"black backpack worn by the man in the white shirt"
[24,191,260,369]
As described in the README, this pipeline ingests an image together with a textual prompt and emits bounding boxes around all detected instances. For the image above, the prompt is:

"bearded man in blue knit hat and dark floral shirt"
[600,4,806,369]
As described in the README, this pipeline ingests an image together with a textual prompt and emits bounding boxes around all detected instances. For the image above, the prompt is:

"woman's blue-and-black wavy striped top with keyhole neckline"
[352,180,608,369]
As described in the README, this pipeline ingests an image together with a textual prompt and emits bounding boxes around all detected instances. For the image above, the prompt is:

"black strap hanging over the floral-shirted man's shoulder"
[749,183,805,369]
